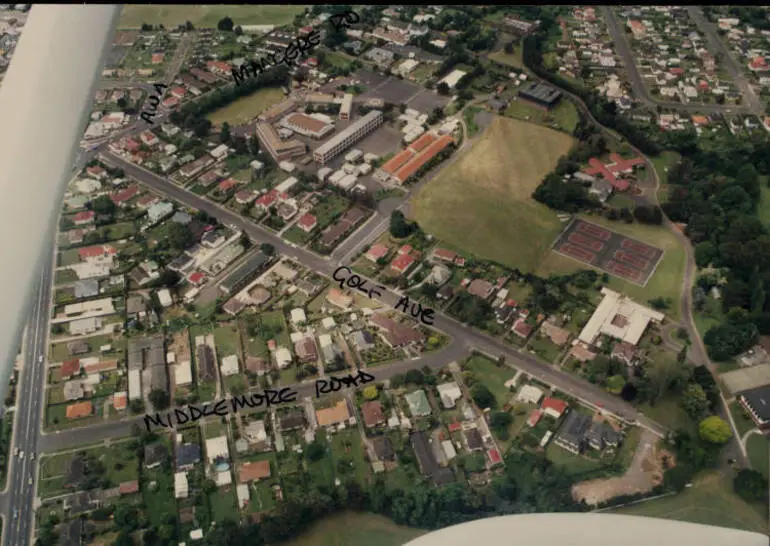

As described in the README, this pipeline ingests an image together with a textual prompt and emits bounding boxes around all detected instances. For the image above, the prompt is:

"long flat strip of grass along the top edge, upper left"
[118,4,305,28]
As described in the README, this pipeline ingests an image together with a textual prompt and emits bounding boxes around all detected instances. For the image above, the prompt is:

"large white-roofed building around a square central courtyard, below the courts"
[578,287,665,345]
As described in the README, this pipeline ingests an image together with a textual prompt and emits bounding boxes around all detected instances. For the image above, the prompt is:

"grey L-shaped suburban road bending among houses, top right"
[601,6,749,114]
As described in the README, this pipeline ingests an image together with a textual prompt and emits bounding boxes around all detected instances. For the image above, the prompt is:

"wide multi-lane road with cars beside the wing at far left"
[1,255,53,546]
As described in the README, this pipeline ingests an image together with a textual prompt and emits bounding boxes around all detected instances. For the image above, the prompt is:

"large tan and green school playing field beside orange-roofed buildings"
[412,117,574,271]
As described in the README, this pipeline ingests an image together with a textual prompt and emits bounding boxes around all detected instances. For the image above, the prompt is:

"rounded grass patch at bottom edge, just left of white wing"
[282,512,425,546]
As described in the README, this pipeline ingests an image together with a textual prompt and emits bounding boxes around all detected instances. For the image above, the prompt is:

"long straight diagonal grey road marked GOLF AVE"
[91,153,663,433]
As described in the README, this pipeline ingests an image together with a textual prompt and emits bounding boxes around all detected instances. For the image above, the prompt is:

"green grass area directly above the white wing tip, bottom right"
[613,474,767,533]
